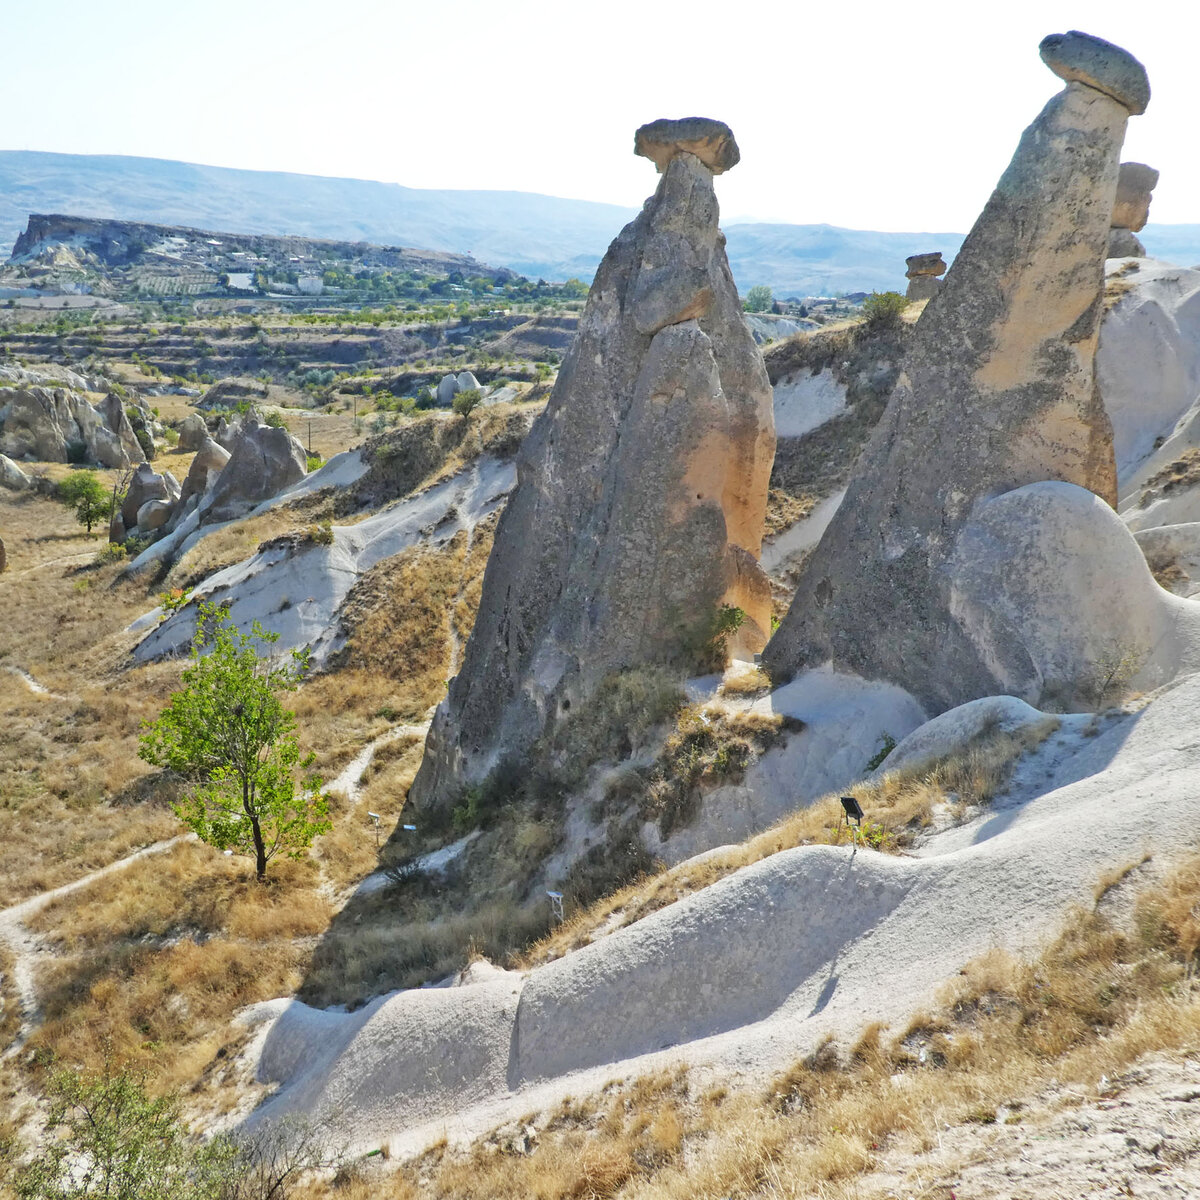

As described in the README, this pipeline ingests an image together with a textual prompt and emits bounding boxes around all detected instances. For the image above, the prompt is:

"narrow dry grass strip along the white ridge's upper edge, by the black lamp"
[520,718,1058,967]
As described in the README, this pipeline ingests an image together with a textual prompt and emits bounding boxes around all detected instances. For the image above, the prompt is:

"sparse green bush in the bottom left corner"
[14,1063,234,1200]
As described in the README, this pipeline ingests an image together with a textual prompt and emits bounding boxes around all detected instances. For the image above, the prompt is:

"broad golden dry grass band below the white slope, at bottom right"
[295,857,1200,1200]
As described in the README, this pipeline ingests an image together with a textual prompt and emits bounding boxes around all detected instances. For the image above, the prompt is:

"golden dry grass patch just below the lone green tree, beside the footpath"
[29,844,330,1088]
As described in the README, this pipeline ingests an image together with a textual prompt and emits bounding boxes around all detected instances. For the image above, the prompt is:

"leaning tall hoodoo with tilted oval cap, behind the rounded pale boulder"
[763,32,1150,712]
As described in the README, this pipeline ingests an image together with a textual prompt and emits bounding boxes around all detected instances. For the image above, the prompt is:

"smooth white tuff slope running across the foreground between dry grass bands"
[248,677,1200,1147]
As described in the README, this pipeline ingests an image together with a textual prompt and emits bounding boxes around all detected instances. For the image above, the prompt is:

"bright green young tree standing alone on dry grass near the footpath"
[138,602,331,880]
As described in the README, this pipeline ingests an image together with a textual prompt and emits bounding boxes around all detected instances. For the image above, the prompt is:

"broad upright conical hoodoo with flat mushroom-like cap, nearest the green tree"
[410,118,775,808]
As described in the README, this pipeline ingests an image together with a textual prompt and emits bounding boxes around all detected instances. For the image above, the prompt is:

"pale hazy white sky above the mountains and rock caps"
[0,0,1200,230]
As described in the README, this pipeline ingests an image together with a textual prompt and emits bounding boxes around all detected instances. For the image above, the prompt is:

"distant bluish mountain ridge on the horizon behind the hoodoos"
[0,150,1200,296]
